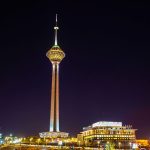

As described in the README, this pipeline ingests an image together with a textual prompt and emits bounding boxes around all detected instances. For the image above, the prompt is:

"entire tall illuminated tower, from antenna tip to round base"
[40,15,68,138]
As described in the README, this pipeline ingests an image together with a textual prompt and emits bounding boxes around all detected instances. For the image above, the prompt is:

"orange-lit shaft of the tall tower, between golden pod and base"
[50,63,59,132]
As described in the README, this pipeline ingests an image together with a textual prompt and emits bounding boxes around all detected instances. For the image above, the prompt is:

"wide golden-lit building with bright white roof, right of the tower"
[78,121,136,148]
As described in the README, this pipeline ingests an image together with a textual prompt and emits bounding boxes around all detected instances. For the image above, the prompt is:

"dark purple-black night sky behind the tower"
[0,0,150,138]
